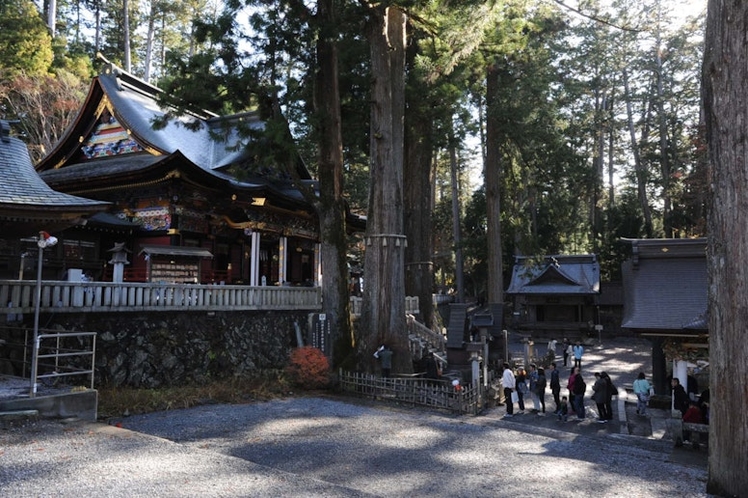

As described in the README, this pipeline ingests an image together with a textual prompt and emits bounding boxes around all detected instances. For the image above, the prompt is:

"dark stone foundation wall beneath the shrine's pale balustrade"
[0,311,307,388]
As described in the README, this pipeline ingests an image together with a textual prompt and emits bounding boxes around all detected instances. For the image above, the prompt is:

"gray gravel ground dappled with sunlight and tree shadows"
[0,341,708,498]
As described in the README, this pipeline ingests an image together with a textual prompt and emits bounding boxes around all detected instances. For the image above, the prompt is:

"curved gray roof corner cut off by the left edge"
[0,132,109,211]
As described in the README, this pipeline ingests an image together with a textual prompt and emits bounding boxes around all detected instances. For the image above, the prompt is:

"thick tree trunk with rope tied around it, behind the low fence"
[356,5,413,372]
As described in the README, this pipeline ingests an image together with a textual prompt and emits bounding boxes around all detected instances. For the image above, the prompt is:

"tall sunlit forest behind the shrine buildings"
[0,0,707,296]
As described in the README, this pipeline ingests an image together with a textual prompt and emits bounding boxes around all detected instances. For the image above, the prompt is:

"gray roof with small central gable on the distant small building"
[507,254,600,295]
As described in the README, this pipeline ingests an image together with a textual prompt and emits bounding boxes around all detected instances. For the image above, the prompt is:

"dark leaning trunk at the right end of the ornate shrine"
[314,0,352,364]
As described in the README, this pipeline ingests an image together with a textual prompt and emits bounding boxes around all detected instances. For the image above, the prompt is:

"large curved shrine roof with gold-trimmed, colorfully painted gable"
[36,64,316,208]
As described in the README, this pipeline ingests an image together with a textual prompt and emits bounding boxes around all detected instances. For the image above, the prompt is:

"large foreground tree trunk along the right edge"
[702,0,748,496]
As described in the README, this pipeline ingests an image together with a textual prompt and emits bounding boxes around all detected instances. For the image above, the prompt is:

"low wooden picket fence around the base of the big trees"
[339,370,485,415]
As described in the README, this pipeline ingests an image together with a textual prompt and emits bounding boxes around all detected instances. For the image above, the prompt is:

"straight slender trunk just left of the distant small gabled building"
[483,61,504,303]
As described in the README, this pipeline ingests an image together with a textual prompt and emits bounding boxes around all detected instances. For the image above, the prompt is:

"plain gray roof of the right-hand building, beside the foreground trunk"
[621,238,708,331]
